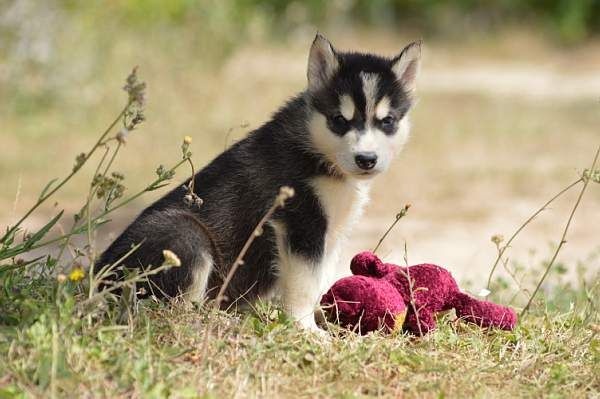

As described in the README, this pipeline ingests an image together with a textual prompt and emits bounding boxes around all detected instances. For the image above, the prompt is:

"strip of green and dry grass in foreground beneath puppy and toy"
[0,278,600,398]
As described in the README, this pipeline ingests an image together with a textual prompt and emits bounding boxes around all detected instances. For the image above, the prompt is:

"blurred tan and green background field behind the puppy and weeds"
[0,0,600,286]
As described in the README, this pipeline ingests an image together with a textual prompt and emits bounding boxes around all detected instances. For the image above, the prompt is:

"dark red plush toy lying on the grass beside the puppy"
[321,252,517,335]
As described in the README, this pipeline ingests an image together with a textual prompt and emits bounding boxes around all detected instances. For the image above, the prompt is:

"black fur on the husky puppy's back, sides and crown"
[96,49,410,306]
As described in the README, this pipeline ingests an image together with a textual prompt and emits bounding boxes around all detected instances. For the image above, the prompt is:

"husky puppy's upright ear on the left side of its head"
[307,33,339,92]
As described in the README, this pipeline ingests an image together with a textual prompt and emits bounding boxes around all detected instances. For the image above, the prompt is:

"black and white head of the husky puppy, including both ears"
[307,34,421,178]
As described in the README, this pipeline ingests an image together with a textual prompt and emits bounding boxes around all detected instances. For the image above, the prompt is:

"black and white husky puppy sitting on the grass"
[96,34,421,329]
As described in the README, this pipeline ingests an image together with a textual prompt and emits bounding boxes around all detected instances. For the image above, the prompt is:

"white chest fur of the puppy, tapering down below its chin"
[312,177,370,288]
